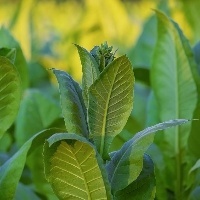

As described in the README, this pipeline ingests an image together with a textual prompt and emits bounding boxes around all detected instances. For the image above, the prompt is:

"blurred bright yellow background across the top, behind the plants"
[0,0,195,80]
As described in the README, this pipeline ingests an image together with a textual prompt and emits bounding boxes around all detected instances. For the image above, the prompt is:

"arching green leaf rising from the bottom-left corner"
[0,129,60,200]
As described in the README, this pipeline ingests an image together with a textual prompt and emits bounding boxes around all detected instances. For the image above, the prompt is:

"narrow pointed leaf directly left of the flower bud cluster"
[75,45,100,108]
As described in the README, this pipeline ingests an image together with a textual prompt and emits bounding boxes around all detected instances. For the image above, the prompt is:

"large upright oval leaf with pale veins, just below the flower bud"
[88,56,134,158]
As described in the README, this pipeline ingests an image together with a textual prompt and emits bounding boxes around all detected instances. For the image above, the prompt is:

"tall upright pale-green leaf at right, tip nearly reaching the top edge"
[151,11,197,154]
